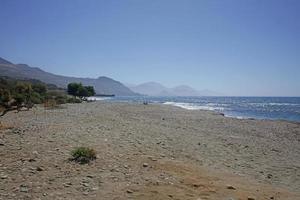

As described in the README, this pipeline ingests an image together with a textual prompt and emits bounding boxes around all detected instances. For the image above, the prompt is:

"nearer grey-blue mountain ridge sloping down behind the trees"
[0,58,137,96]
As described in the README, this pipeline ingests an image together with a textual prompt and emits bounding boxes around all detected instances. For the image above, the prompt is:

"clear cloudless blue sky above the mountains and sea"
[0,0,300,96]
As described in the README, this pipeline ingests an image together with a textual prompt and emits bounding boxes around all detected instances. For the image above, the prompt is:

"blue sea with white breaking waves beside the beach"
[90,96,300,122]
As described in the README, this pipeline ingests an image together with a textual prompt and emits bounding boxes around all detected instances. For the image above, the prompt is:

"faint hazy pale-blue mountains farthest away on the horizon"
[129,82,221,96]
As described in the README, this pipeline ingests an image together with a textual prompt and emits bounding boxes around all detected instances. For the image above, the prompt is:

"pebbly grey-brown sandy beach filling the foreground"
[0,101,300,200]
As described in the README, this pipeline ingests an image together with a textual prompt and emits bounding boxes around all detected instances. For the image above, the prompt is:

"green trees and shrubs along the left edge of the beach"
[0,77,95,116]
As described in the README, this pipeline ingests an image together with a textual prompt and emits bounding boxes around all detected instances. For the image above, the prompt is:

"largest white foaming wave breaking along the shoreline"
[163,101,225,111]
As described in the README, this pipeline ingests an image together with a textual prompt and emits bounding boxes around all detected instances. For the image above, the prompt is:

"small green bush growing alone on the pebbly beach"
[71,147,96,164]
